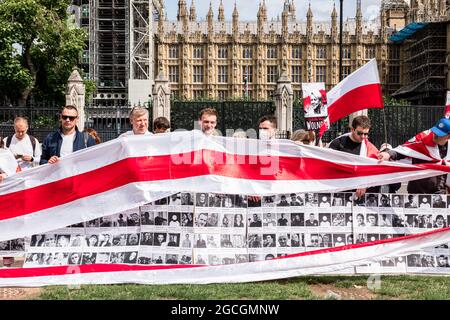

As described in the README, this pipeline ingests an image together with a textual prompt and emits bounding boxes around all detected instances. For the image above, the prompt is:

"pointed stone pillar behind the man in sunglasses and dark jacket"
[66,68,86,131]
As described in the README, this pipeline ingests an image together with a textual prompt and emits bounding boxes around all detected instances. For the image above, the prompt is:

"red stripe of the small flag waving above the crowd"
[328,83,384,123]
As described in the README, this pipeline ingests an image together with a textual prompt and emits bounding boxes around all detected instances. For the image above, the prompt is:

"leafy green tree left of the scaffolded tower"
[0,0,86,105]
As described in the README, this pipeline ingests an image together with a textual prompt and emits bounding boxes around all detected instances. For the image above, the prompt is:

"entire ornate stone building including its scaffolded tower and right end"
[78,0,450,104]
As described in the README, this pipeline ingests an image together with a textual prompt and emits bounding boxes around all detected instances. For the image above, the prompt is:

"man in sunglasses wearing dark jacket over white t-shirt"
[40,105,95,164]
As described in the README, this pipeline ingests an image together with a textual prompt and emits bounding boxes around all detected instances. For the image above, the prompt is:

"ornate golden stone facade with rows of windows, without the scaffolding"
[154,0,442,100]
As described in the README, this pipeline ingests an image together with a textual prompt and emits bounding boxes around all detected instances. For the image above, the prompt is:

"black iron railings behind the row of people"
[0,101,444,146]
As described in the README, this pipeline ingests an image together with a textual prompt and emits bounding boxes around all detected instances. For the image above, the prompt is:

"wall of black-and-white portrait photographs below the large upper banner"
[22,192,450,273]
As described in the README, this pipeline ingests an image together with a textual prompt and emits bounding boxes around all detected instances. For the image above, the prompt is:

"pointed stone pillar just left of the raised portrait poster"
[275,70,294,133]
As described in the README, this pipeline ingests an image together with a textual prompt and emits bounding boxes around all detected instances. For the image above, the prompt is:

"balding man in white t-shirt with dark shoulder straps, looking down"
[3,117,42,170]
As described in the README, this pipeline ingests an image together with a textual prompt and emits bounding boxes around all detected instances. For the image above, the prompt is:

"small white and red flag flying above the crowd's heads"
[320,59,384,136]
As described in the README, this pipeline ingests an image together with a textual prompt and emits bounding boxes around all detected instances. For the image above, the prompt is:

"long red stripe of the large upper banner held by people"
[0,150,442,220]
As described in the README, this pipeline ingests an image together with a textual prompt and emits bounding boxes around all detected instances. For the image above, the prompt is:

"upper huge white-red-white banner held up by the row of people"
[0,131,450,241]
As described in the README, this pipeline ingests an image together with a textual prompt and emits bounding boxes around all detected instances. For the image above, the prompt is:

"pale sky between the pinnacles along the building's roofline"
[165,0,390,21]
